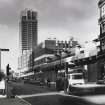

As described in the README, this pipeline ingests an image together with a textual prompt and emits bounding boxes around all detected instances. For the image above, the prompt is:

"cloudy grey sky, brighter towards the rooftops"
[0,0,99,70]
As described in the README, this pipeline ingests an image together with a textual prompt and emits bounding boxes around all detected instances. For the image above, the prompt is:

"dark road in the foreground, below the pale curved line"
[24,93,96,105]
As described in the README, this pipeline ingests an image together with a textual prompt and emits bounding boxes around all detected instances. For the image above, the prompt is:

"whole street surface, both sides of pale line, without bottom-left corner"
[5,82,105,105]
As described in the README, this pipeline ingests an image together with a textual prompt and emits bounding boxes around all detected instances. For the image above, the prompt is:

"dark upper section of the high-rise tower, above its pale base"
[19,9,37,54]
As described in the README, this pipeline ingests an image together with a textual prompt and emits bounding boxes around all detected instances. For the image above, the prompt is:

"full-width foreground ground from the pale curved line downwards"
[0,91,105,105]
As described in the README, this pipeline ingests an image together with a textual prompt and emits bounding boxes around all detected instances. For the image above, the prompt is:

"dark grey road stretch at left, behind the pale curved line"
[10,82,56,96]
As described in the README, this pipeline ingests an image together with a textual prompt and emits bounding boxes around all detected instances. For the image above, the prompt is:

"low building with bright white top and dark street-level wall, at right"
[74,41,99,82]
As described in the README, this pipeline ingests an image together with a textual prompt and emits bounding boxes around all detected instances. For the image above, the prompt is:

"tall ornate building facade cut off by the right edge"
[98,0,105,81]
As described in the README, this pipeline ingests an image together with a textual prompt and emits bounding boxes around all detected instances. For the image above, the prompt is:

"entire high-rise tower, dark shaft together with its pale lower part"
[18,9,38,77]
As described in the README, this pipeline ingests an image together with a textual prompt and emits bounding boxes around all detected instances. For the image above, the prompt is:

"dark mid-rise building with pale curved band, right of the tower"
[34,40,78,82]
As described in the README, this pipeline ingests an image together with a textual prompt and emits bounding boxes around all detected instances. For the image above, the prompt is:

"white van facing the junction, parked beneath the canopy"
[68,73,85,85]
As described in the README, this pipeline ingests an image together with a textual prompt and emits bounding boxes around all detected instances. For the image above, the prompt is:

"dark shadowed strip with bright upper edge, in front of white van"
[69,84,105,96]
